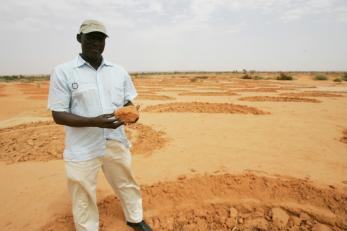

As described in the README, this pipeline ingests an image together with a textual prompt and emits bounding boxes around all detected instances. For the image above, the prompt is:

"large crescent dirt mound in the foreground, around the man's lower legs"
[42,174,347,231]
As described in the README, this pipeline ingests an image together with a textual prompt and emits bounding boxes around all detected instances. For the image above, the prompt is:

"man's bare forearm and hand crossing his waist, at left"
[52,111,124,129]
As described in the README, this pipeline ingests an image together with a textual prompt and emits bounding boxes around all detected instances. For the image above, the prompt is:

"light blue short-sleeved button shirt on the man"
[48,56,137,161]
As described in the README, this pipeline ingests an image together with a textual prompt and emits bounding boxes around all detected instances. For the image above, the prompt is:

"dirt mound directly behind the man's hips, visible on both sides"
[0,121,167,163]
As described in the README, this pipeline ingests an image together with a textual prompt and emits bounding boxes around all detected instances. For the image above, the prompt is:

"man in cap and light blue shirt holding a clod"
[48,20,152,231]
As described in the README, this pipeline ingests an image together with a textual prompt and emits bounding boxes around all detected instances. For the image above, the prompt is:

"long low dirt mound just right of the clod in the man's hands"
[143,102,269,115]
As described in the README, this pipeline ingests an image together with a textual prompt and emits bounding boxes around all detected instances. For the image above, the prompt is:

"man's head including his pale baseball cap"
[76,20,108,61]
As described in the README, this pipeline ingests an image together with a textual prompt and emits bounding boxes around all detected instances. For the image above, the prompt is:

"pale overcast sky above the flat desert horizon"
[0,0,347,75]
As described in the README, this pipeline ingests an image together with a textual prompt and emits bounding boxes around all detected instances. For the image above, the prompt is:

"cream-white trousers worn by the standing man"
[65,140,143,231]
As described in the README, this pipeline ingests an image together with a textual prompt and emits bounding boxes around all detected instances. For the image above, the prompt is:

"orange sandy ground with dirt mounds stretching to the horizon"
[0,73,347,231]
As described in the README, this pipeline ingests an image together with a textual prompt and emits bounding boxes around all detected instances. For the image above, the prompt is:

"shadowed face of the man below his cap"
[79,32,106,60]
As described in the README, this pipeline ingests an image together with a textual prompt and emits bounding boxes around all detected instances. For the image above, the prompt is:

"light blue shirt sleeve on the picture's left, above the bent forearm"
[48,68,71,112]
